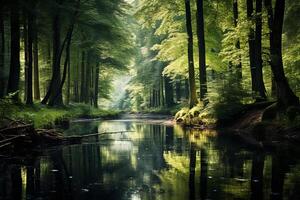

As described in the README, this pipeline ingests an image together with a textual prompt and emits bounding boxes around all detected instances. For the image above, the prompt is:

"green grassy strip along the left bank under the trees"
[0,99,119,128]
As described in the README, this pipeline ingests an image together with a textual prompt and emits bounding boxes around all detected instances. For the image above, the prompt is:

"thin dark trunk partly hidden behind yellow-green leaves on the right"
[233,0,243,81]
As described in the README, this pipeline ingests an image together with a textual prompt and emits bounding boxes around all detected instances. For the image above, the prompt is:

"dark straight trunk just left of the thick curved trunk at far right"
[255,0,267,99]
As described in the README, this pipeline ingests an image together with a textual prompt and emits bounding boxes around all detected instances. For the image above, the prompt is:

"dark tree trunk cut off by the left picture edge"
[0,7,5,98]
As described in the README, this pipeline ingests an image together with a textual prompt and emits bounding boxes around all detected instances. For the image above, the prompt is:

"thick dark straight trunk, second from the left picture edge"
[7,0,20,100]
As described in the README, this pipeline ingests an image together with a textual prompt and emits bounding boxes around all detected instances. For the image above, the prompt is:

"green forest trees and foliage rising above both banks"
[0,0,300,117]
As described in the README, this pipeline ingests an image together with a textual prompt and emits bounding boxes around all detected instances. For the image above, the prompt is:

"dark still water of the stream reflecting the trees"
[0,121,300,200]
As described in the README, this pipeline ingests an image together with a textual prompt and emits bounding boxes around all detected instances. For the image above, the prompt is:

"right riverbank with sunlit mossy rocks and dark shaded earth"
[175,102,300,149]
